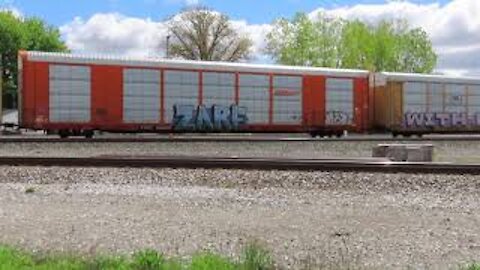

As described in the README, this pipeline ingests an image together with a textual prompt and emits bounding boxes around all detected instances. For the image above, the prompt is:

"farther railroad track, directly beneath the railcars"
[0,135,480,143]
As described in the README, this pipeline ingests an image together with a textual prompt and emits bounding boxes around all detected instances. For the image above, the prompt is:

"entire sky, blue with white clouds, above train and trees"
[0,0,480,76]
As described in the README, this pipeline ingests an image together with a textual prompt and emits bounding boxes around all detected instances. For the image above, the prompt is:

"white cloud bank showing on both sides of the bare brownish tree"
[60,13,270,60]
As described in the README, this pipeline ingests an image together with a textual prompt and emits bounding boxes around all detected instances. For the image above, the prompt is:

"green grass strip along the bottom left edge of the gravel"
[0,244,274,270]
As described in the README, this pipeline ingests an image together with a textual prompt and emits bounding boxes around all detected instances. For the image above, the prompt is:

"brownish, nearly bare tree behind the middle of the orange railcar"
[167,7,252,62]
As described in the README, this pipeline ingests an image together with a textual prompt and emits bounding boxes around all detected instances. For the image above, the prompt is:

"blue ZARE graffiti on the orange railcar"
[172,104,248,131]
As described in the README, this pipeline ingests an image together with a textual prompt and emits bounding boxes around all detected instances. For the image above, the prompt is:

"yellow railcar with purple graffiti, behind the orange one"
[375,73,480,135]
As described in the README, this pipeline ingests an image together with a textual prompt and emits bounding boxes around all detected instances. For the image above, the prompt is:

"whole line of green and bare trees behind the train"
[0,7,437,108]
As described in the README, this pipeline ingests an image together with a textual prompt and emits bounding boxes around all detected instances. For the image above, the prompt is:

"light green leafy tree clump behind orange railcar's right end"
[267,14,437,73]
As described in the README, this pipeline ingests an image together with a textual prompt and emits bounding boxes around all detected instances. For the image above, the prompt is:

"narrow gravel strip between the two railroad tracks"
[0,141,480,163]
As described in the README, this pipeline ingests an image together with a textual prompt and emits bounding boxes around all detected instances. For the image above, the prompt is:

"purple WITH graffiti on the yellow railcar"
[404,112,480,127]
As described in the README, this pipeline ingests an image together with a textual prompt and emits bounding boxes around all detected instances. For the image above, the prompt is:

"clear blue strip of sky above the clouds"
[0,0,449,26]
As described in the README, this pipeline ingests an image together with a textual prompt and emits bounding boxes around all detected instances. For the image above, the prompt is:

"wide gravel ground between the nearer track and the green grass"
[0,167,480,269]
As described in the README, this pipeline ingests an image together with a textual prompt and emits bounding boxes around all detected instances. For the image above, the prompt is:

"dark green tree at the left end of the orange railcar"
[0,11,68,108]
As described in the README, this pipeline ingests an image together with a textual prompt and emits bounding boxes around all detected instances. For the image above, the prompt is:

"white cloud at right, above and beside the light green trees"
[310,0,480,74]
